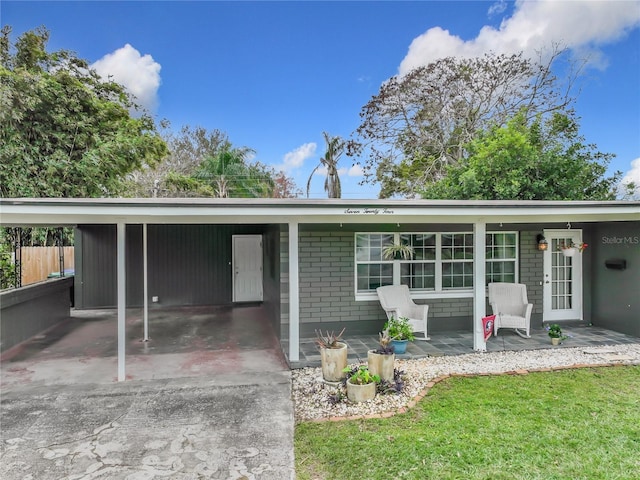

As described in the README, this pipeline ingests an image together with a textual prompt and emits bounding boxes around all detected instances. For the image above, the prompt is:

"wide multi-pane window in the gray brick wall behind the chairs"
[355,232,518,294]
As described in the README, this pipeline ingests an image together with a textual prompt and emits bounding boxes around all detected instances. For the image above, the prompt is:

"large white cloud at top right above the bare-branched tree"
[399,0,640,75]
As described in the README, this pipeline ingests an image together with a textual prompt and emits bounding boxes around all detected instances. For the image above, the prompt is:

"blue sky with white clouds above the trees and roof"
[0,0,640,198]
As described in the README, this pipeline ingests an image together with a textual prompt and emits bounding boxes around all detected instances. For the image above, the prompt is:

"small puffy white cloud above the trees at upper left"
[91,43,161,111]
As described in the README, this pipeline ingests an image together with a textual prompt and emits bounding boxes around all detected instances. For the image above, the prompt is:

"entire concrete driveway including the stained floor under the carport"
[0,307,295,480]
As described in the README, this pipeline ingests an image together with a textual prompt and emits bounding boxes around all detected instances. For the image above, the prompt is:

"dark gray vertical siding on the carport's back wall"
[77,225,275,308]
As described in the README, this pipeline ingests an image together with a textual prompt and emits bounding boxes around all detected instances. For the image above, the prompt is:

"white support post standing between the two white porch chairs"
[473,222,487,352]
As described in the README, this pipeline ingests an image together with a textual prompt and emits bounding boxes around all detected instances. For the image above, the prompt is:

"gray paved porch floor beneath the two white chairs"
[283,322,640,368]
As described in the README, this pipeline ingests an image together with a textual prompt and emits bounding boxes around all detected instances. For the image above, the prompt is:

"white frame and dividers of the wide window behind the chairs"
[353,231,520,301]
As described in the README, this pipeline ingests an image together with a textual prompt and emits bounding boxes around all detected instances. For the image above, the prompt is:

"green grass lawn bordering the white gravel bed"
[295,366,640,480]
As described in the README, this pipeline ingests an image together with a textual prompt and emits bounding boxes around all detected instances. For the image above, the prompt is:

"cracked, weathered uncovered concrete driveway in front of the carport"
[0,371,295,480]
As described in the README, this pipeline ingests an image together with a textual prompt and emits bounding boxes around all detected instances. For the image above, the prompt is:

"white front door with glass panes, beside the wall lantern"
[543,230,582,322]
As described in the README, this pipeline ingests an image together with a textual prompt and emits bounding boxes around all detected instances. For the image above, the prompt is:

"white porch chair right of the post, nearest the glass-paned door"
[489,283,533,338]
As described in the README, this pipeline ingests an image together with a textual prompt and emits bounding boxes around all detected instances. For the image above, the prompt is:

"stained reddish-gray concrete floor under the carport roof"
[0,305,288,388]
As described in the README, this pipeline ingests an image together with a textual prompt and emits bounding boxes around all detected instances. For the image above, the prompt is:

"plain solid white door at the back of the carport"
[232,235,262,302]
